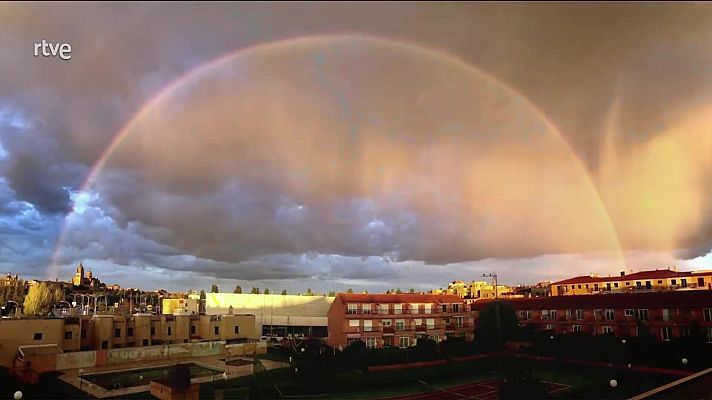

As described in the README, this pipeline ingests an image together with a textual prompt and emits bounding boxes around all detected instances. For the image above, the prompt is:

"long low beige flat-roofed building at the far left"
[0,314,258,367]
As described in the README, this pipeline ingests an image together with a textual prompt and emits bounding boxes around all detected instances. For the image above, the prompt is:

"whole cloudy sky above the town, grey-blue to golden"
[0,2,712,293]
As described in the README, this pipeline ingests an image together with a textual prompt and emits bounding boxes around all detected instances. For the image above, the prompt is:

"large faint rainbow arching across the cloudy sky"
[48,34,624,276]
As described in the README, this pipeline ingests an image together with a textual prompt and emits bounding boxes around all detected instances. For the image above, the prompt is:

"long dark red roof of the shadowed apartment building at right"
[470,290,712,311]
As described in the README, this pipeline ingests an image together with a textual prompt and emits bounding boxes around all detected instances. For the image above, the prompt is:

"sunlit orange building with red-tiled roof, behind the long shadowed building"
[551,269,712,296]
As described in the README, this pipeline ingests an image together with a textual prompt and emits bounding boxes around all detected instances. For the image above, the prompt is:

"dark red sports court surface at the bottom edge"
[387,379,568,400]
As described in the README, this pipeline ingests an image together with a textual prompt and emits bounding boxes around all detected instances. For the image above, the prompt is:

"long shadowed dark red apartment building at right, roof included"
[470,290,712,343]
